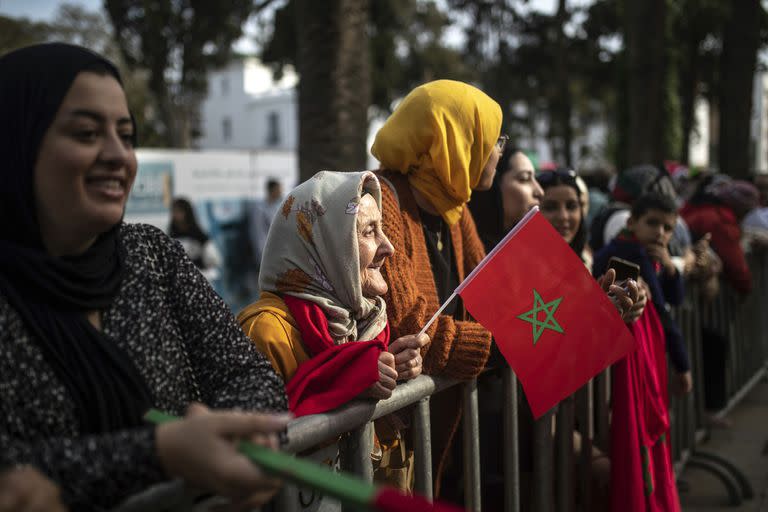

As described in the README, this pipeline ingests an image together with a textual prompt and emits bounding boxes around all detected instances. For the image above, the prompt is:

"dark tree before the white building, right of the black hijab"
[104,0,255,147]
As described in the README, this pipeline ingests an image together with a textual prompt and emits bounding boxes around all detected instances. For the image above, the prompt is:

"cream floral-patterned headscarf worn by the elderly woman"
[259,171,387,344]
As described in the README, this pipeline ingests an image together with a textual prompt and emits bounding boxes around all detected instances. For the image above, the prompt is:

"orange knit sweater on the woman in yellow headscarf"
[377,171,491,379]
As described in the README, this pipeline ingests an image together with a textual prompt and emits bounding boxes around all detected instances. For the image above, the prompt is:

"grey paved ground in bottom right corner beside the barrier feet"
[680,379,768,512]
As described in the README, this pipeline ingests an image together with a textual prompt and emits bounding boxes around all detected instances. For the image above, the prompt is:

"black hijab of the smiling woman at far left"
[0,43,152,434]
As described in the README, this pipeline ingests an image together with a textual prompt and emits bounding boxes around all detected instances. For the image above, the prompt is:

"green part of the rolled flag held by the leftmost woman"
[144,409,378,510]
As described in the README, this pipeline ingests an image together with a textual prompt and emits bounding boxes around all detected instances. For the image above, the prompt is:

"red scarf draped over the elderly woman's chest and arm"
[283,295,389,417]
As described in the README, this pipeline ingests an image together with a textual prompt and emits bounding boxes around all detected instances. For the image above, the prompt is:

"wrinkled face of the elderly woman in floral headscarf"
[357,194,395,298]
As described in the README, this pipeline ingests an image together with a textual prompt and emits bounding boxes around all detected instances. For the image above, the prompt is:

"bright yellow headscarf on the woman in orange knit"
[371,80,501,225]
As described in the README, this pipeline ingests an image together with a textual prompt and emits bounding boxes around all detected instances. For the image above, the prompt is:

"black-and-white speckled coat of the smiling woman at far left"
[0,224,287,510]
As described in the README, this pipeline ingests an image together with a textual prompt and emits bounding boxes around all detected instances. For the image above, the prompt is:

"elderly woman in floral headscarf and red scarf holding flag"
[238,171,429,416]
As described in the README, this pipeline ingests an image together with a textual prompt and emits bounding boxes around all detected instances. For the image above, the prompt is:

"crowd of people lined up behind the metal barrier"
[0,43,768,511]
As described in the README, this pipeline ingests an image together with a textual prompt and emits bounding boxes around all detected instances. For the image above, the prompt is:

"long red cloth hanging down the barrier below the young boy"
[611,301,680,512]
